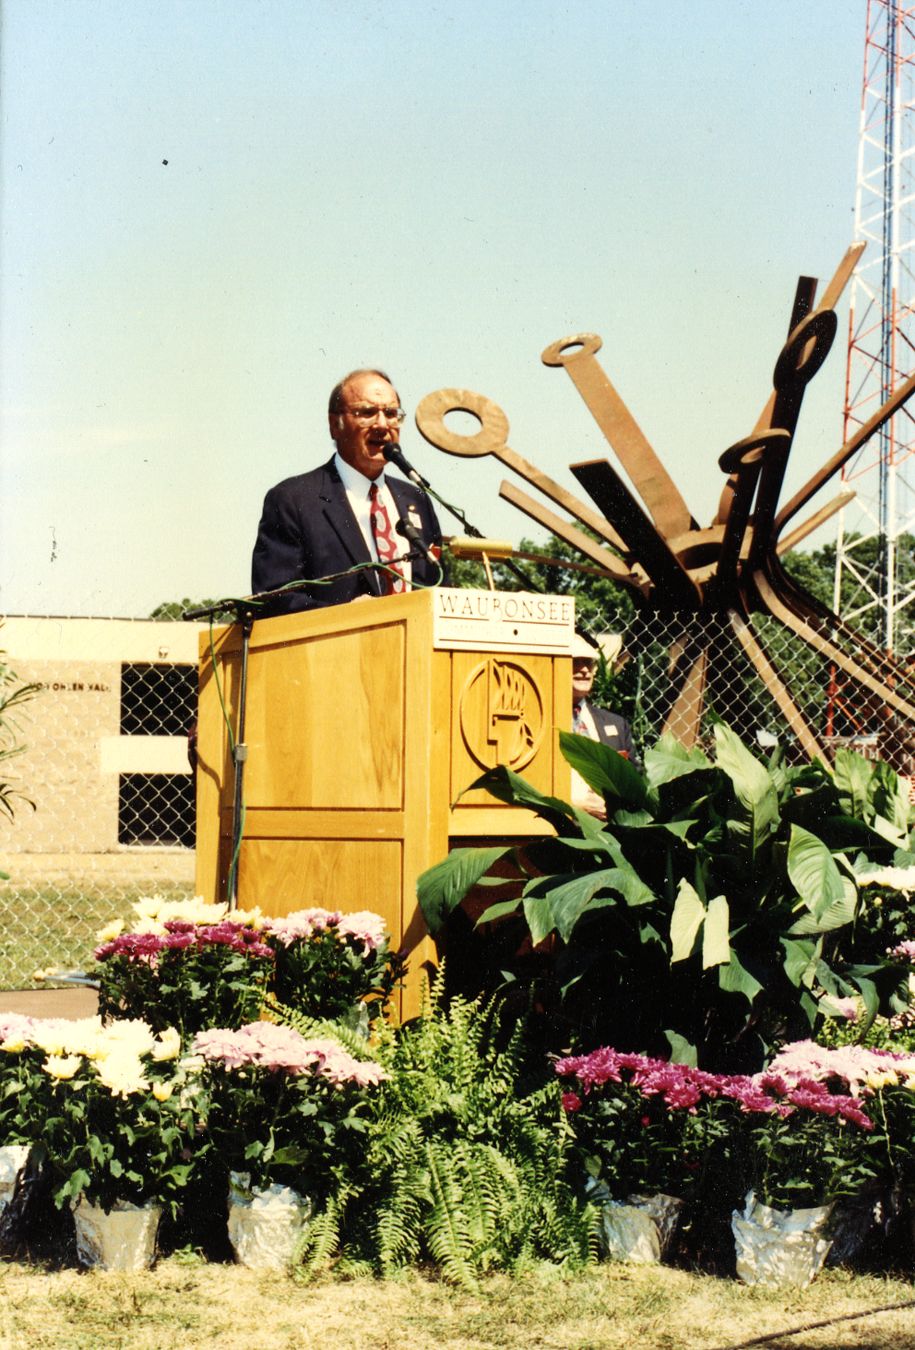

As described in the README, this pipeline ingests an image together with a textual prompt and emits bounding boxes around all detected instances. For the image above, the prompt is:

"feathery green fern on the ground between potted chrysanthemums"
[326,973,595,1288]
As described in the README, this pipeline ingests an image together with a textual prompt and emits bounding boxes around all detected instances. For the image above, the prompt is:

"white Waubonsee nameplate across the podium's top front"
[432,586,575,656]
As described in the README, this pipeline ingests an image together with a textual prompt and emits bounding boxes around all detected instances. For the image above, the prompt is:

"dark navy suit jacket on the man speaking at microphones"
[251,459,441,614]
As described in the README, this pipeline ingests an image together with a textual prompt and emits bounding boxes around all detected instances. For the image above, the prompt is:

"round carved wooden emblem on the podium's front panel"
[460,656,544,770]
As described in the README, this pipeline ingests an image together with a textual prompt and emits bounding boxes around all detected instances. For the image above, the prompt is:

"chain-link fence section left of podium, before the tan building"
[0,617,198,990]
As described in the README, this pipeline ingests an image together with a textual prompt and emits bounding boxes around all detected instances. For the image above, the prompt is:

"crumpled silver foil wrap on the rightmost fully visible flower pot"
[730,1191,833,1288]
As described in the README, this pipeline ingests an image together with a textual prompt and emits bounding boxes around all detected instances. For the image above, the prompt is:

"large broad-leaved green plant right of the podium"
[418,724,911,1071]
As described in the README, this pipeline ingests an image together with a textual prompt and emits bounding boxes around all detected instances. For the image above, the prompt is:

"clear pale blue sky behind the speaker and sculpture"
[0,0,866,616]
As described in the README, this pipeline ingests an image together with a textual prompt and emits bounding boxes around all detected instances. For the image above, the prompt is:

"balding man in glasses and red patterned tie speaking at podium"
[251,370,441,614]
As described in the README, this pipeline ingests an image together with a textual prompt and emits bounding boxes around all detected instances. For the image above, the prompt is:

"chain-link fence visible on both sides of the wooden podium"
[0,606,915,990]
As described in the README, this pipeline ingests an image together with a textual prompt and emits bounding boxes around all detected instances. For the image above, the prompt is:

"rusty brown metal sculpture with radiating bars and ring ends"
[416,244,915,757]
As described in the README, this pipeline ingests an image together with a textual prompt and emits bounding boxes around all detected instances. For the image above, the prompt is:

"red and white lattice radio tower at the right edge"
[835,0,915,656]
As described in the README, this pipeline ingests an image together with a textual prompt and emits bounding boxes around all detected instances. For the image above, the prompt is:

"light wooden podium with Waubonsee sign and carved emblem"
[197,587,574,1017]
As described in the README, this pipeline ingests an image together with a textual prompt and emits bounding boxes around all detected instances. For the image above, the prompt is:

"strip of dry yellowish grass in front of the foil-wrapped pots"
[0,1258,915,1350]
